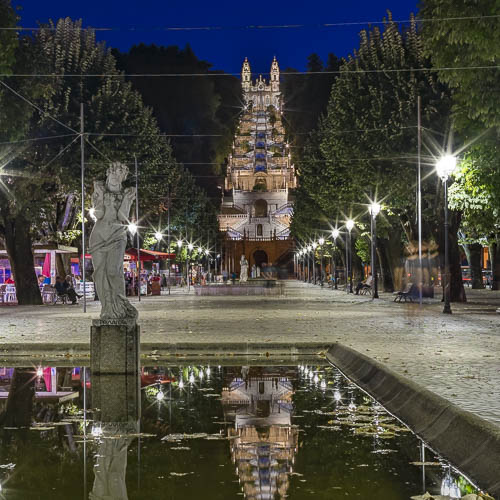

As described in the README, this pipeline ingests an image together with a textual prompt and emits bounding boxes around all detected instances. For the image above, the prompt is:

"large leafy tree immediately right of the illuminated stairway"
[294,16,465,300]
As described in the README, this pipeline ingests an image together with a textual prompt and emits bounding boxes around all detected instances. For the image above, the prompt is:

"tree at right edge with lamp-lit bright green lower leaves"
[419,0,500,290]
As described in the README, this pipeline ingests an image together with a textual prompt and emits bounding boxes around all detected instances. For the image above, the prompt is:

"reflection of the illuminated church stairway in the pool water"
[222,367,298,499]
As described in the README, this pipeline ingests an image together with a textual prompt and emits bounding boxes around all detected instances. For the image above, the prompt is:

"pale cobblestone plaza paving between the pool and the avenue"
[0,281,500,425]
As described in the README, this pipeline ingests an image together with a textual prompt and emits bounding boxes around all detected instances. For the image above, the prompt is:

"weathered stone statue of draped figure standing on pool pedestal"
[89,163,137,320]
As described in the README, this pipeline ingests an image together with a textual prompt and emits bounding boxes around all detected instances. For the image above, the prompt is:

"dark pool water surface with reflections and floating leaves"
[0,361,480,500]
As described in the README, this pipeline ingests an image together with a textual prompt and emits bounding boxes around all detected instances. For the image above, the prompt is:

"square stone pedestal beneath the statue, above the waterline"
[90,319,140,375]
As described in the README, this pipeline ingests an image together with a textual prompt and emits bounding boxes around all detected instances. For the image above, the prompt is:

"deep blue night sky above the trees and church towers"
[12,0,418,73]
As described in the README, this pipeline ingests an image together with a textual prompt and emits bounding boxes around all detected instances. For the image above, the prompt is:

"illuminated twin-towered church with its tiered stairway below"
[219,58,297,272]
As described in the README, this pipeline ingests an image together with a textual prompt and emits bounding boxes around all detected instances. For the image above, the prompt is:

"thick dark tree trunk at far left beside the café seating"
[5,214,42,305]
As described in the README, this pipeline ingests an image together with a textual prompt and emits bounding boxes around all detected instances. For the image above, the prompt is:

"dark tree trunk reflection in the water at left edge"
[0,367,35,427]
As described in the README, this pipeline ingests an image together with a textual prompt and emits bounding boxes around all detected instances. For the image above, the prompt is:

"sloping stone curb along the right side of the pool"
[326,344,500,497]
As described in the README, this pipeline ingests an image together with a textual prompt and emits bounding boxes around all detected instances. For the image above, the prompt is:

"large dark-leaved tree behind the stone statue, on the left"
[0,19,207,304]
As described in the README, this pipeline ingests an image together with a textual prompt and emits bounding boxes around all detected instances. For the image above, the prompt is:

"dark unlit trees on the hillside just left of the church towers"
[113,44,242,196]
